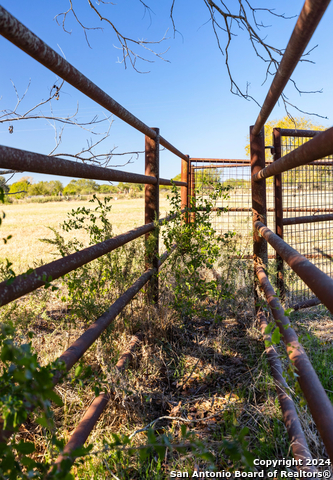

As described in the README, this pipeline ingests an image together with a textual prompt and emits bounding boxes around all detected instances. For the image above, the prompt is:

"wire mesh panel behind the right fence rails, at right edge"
[281,130,333,305]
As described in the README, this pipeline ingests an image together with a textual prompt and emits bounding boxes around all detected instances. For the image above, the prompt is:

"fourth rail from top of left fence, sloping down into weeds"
[0,245,176,443]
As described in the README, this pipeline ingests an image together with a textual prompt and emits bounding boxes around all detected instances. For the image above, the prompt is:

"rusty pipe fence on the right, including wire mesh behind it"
[250,0,333,461]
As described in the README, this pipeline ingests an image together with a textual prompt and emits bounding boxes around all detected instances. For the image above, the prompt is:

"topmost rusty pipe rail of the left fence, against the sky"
[0,5,188,161]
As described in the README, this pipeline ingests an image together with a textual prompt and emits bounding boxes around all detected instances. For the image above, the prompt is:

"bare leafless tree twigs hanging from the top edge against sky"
[55,0,321,117]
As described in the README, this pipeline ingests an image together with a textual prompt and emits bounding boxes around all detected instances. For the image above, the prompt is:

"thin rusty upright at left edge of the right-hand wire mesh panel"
[273,128,285,301]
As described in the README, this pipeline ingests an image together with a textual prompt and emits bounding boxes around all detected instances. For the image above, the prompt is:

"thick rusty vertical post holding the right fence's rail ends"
[250,126,268,304]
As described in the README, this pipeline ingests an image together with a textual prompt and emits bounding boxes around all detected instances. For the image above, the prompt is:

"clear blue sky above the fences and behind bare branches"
[0,0,333,184]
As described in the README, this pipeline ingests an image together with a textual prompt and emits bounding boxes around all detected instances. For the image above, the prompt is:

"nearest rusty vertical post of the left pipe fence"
[145,128,160,304]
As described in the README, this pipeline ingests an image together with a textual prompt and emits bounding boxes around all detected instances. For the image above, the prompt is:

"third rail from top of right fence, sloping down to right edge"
[254,221,333,313]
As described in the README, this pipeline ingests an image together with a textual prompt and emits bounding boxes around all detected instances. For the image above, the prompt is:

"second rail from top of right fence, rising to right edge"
[252,127,333,182]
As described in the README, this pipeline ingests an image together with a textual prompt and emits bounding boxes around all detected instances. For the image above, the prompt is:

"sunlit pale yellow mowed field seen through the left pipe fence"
[0,196,169,273]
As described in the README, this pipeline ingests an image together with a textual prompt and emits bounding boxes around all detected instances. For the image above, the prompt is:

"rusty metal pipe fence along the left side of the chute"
[0,6,189,454]
